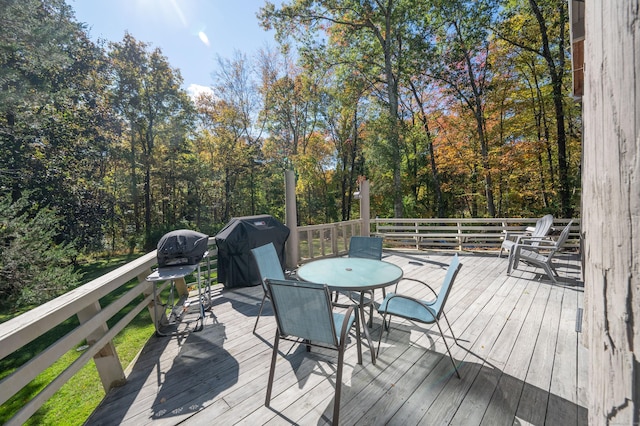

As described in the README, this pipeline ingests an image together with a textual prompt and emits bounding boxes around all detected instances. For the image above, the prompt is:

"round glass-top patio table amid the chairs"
[296,257,403,364]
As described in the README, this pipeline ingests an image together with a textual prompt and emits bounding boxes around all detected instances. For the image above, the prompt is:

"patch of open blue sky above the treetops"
[68,0,276,95]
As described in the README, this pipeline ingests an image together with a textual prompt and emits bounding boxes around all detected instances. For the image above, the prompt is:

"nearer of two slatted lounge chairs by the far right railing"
[509,221,573,284]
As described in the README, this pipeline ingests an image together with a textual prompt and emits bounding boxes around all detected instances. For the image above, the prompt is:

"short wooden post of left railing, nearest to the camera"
[77,302,126,392]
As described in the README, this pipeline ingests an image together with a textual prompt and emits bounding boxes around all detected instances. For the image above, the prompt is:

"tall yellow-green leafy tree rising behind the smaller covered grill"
[109,33,193,250]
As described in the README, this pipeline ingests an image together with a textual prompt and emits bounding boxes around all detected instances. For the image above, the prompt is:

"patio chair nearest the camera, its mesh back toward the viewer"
[265,279,362,425]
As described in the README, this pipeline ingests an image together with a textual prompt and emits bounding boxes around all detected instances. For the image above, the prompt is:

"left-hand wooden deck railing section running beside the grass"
[0,238,217,425]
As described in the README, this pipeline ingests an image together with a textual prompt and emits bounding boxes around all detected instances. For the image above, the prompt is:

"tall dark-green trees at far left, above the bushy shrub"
[0,0,111,250]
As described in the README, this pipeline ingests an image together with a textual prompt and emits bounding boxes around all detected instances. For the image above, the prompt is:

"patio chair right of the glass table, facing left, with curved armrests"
[377,254,462,378]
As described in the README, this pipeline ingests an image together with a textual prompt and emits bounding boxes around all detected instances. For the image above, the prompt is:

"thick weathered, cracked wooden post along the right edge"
[582,0,640,425]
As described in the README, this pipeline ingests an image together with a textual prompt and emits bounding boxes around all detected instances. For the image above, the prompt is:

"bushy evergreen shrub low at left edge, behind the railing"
[0,196,79,308]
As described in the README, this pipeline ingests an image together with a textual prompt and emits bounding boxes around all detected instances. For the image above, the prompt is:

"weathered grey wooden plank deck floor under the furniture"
[87,251,587,426]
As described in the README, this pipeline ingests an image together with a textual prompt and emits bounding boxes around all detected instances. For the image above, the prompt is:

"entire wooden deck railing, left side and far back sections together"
[0,218,580,425]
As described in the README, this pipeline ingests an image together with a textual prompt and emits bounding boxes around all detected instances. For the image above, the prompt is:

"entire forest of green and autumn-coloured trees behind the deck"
[0,0,582,306]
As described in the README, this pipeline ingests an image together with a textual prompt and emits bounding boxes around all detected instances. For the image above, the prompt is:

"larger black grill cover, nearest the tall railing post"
[216,215,289,288]
